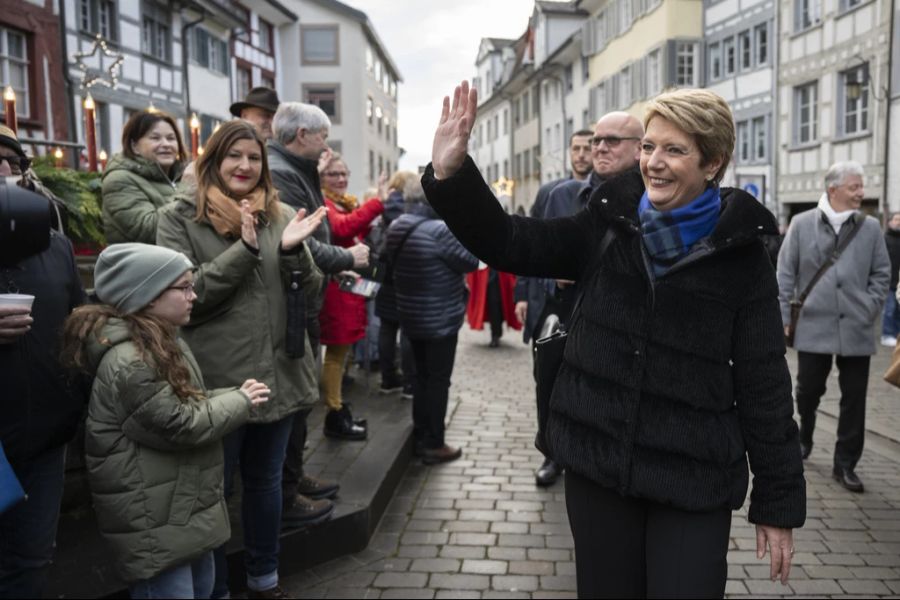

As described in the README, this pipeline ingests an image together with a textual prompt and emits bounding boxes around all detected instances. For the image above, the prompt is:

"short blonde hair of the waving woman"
[644,89,735,183]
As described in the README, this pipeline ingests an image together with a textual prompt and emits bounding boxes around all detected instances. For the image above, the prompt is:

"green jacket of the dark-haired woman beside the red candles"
[101,154,183,244]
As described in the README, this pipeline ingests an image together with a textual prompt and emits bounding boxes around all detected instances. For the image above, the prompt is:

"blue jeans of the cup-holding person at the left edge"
[0,446,66,598]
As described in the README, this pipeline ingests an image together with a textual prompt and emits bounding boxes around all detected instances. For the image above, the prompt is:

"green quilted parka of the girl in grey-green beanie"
[85,319,250,582]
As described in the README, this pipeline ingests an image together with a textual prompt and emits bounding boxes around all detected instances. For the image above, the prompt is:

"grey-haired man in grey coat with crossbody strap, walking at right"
[778,161,891,492]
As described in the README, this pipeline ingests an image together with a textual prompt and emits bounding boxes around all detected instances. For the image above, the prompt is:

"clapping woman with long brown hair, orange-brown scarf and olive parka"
[157,120,326,597]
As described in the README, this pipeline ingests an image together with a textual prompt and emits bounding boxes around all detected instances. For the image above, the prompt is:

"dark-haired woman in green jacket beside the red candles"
[101,110,186,244]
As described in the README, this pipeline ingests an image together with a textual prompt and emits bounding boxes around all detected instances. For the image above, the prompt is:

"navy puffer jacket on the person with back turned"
[386,204,478,340]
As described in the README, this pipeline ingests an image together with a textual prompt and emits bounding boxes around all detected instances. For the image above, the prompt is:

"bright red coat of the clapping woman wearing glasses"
[319,199,384,346]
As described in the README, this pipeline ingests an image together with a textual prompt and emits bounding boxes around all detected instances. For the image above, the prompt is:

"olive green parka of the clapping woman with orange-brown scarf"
[156,193,322,423]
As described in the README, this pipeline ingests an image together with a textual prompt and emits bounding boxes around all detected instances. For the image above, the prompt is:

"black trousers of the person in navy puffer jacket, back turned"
[410,334,456,449]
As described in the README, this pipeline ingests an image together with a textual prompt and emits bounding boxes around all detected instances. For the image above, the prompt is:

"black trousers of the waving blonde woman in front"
[566,471,731,598]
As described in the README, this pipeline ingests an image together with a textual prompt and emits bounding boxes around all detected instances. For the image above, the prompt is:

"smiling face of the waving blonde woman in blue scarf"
[641,117,722,210]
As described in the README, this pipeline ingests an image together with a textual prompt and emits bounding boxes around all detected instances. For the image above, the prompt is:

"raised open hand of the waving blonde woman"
[431,81,478,179]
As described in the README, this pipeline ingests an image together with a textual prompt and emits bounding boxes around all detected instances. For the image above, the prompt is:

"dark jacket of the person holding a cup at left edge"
[0,232,88,464]
